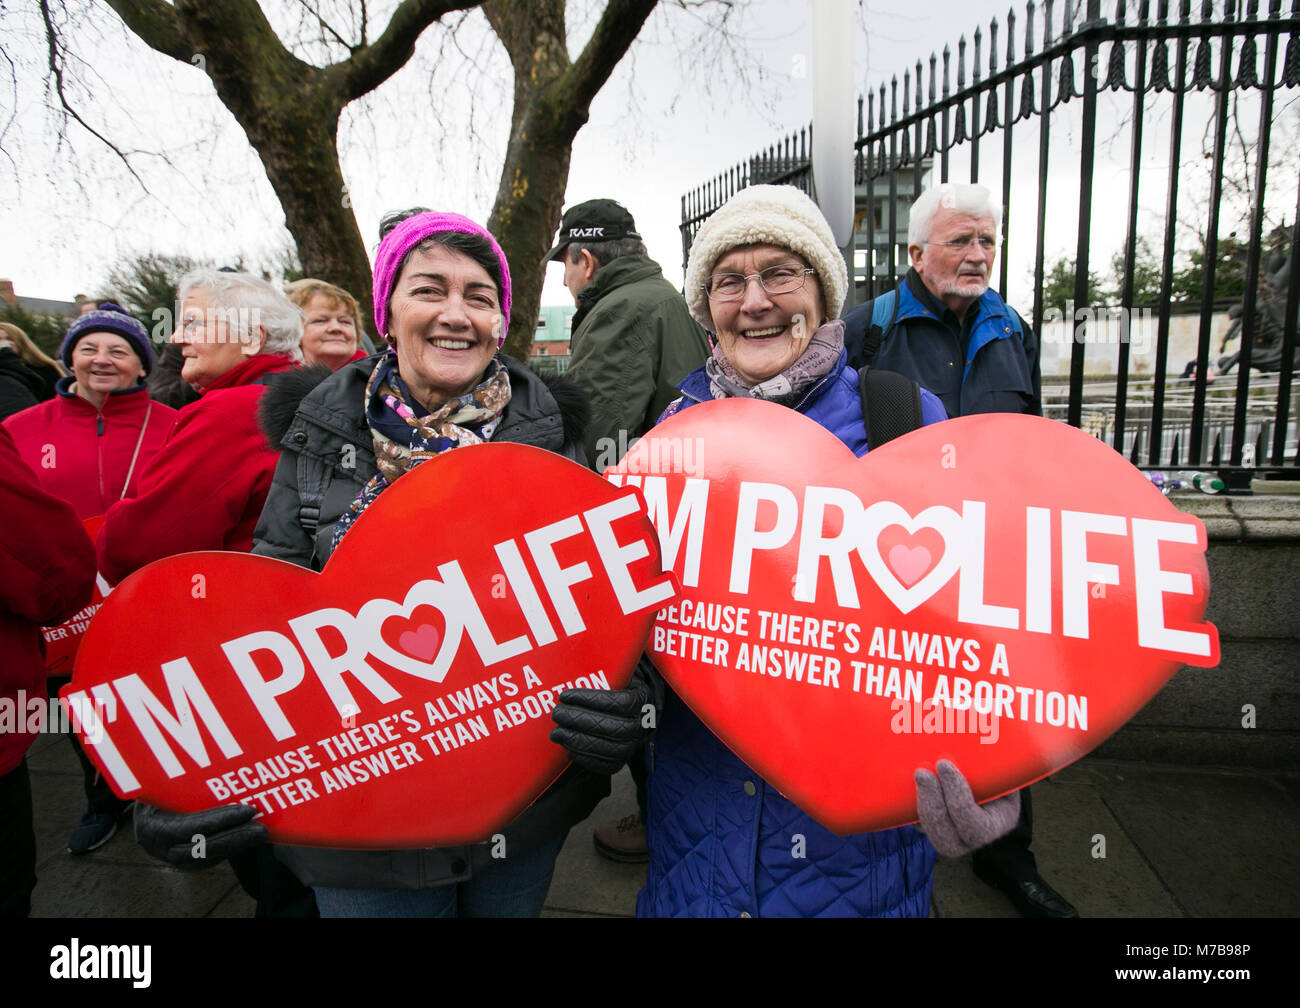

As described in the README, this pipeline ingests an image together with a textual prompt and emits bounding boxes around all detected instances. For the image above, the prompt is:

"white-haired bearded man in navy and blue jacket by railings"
[844,183,1078,917]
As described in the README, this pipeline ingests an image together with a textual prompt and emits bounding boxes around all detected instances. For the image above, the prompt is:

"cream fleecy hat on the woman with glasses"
[686,186,849,332]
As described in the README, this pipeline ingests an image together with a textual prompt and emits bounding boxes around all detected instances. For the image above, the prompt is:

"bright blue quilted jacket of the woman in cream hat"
[637,355,945,917]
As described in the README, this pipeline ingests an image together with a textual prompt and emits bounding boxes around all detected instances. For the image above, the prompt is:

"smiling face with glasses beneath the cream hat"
[709,245,826,385]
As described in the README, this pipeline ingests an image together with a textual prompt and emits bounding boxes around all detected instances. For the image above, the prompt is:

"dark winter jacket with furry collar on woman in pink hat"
[252,356,610,888]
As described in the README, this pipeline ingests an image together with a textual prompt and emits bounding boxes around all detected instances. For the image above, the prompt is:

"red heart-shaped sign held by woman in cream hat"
[606,399,1218,834]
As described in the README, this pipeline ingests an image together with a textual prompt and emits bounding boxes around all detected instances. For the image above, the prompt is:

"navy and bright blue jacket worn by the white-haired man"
[844,269,1043,416]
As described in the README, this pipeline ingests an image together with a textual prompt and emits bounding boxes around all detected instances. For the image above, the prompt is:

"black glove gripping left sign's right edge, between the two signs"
[551,679,650,775]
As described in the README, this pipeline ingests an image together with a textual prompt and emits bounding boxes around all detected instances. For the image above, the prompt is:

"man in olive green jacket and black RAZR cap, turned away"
[546,199,709,472]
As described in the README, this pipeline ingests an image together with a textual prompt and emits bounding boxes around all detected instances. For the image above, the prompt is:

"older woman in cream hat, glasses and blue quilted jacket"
[637,186,1019,917]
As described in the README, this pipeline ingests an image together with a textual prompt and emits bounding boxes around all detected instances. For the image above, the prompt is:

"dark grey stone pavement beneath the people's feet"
[29,735,1300,918]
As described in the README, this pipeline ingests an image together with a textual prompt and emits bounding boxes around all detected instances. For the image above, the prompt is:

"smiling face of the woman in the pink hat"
[389,245,502,411]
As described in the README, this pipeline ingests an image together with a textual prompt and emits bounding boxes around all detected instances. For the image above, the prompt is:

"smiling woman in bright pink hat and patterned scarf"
[137,211,644,917]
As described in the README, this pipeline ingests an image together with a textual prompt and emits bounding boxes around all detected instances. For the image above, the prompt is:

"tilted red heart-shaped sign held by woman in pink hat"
[62,445,673,848]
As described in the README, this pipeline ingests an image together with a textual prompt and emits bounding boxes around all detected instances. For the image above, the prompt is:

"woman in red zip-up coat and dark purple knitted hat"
[4,302,176,855]
